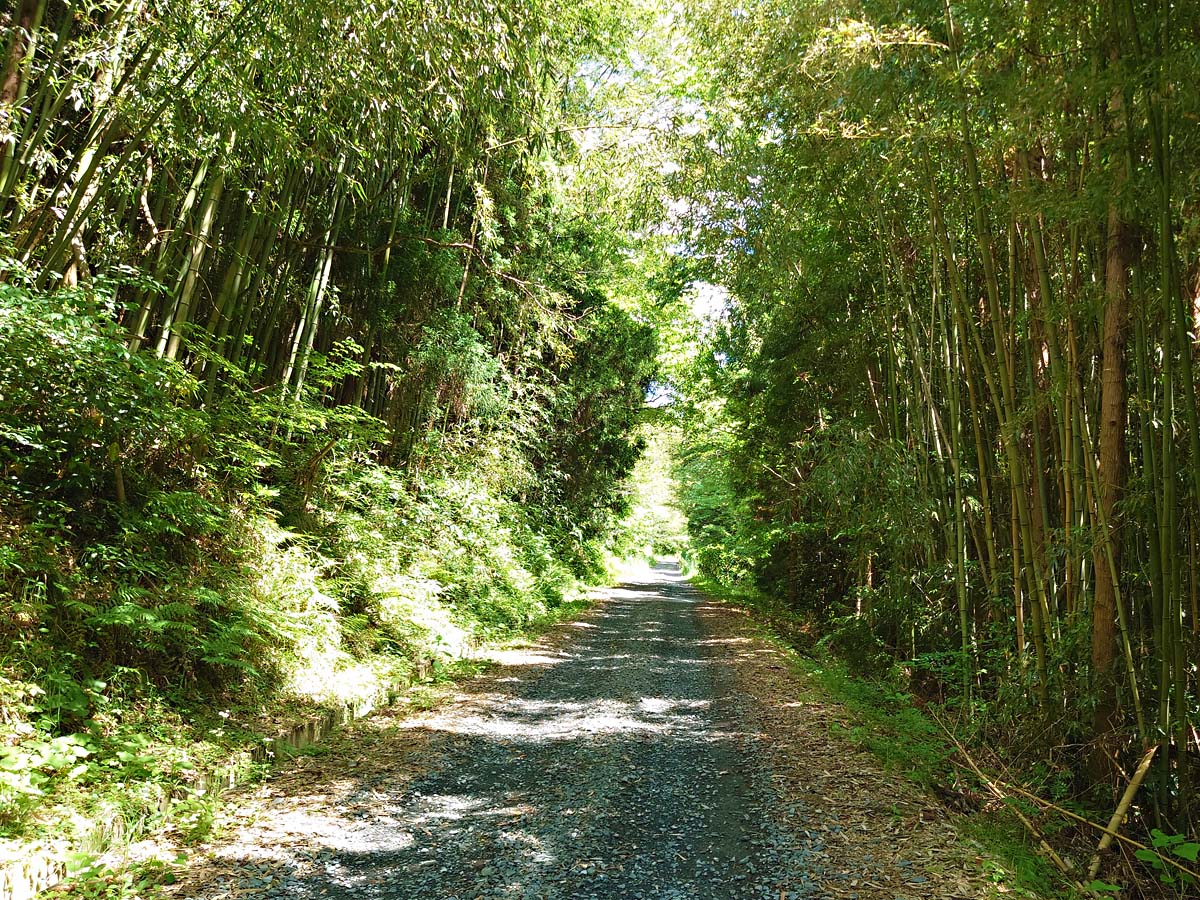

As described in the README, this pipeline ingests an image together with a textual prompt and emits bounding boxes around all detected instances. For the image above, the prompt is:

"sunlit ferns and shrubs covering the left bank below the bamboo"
[0,283,638,889]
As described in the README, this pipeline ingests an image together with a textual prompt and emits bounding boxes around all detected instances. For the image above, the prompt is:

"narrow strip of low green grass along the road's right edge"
[692,576,1078,900]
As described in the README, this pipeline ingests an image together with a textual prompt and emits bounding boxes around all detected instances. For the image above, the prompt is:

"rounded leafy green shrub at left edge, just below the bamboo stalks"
[0,281,197,508]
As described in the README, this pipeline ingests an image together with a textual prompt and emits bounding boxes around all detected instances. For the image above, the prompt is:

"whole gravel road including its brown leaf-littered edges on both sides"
[175,566,1003,900]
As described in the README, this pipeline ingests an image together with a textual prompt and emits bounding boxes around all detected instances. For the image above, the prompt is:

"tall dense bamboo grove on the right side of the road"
[678,0,1200,830]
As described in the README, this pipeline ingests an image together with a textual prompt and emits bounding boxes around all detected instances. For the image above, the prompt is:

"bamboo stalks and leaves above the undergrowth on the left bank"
[0,0,648,444]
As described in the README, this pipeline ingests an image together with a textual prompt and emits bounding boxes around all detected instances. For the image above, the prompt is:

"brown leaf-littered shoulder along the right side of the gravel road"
[697,595,1060,900]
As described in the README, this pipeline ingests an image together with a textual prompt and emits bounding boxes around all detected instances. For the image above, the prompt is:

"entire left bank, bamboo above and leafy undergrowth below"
[0,0,655,873]
